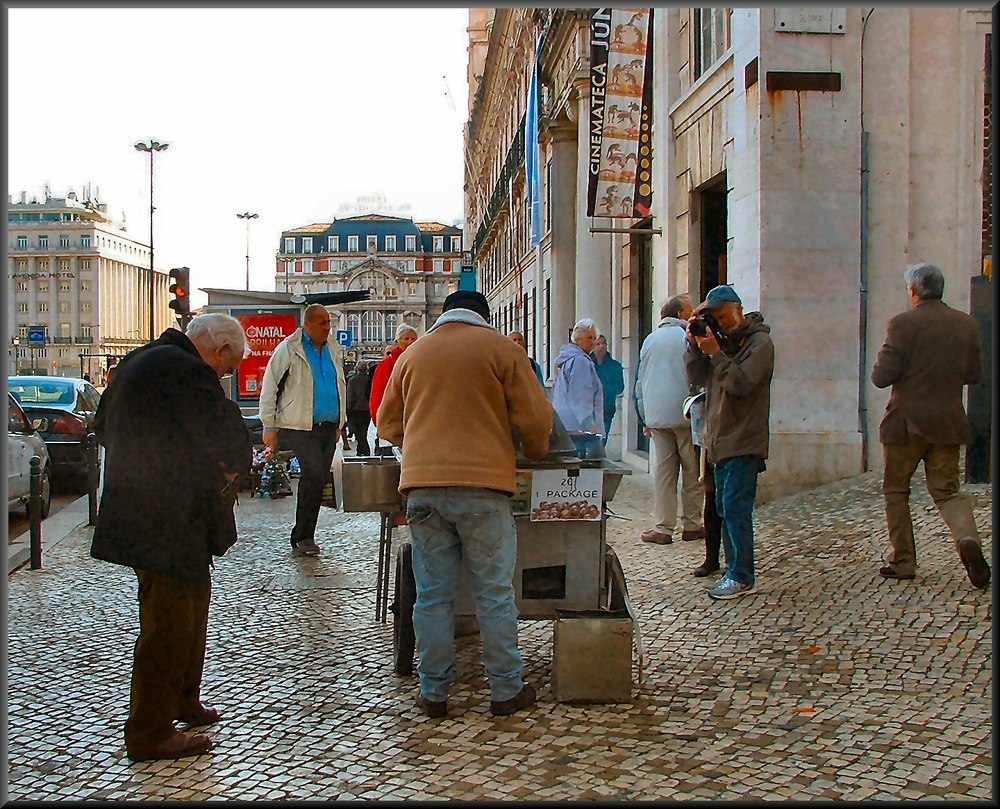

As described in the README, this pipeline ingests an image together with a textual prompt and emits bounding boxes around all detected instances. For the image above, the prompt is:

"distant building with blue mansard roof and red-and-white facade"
[274,213,462,359]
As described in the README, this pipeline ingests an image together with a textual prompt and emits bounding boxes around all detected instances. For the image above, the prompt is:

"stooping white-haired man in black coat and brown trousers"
[91,314,251,761]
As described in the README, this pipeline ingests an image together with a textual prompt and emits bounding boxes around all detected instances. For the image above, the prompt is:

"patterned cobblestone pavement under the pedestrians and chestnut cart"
[8,474,993,801]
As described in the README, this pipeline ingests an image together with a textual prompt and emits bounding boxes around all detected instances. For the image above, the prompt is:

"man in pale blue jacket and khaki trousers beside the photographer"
[635,295,705,545]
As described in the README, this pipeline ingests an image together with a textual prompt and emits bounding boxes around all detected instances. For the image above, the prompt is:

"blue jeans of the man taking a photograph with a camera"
[715,455,762,584]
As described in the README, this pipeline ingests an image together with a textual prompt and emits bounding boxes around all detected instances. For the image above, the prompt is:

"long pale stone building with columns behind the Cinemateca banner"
[465,6,992,498]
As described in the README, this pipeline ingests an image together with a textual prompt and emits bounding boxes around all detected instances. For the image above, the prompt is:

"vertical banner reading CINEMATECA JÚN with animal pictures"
[587,8,653,219]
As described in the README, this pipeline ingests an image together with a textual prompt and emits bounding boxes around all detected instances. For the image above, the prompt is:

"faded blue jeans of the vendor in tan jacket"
[406,486,523,702]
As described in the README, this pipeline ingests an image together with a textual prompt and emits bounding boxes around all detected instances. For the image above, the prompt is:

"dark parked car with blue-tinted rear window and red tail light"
[7,376,101,493]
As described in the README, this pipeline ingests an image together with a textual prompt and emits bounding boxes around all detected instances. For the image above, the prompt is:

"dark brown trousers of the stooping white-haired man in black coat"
[125,568,212,750]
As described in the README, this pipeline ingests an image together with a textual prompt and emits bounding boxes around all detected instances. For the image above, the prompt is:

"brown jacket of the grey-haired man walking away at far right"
[872,300,982,444]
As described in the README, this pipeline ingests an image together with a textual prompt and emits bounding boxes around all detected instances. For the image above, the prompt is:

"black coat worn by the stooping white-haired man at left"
[91,329,251,579]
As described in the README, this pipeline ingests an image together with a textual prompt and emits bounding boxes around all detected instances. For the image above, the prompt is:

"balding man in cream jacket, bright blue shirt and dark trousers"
[260,303,347,556]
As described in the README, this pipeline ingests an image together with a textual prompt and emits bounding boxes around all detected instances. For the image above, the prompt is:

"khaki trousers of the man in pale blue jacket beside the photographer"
[649,426,704,534]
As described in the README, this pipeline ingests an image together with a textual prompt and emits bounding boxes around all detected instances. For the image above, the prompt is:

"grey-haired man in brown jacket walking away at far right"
[872,264,990,587]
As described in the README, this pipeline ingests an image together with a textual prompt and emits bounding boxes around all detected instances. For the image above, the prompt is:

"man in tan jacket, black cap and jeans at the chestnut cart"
[377,290,552,717]
